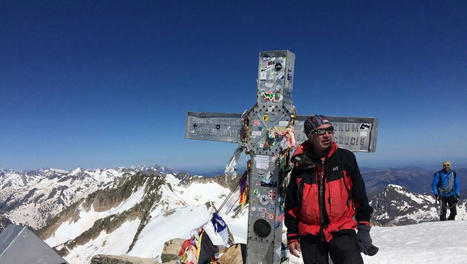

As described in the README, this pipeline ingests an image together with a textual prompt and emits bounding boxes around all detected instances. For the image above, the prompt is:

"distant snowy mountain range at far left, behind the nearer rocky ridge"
[0,166,188,229]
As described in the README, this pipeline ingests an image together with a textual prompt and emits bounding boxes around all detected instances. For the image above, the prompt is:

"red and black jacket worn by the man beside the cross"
[285,141,373,243]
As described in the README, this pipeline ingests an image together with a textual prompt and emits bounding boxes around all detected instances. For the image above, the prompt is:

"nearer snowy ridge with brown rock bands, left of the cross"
[39,172,247,263]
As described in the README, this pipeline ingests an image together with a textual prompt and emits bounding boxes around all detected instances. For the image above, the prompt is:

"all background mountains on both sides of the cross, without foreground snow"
[0,166,467,263]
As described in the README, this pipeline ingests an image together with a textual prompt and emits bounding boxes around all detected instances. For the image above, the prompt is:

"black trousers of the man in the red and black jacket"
[300,230,363,264]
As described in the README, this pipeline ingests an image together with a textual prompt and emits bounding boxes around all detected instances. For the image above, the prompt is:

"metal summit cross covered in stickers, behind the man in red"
[185,50,378,264]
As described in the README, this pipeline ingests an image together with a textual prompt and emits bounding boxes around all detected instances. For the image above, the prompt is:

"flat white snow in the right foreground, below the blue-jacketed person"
[288,221,467,264]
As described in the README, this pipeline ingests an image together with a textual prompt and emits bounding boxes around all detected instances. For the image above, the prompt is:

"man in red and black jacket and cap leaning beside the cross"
[285,115,378,264]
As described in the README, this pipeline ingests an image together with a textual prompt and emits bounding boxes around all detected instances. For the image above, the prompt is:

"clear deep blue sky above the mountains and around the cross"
[0,1,467,169]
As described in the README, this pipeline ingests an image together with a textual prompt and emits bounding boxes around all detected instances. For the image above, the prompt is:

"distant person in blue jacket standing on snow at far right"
[431,161,460,221]
